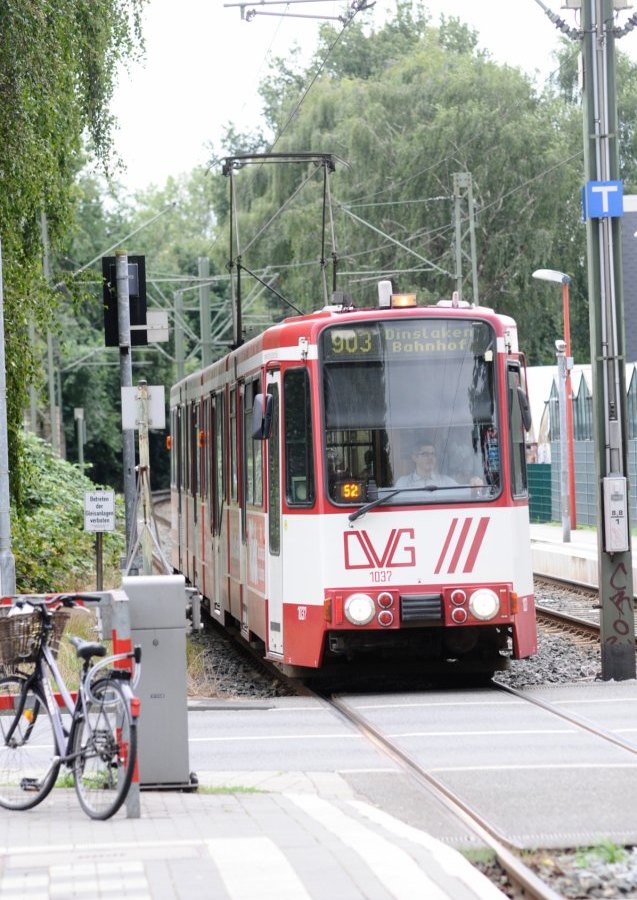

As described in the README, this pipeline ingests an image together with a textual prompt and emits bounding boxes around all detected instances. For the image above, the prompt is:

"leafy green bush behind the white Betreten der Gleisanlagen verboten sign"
[11,434,124,593]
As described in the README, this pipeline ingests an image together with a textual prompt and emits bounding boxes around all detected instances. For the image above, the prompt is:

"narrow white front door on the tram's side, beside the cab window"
[266,371,283,655]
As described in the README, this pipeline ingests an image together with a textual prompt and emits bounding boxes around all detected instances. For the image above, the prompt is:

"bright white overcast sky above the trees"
[113,0,637,196]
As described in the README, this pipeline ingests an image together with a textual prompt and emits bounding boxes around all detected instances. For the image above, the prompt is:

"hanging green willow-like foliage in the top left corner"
[0,0,144,503]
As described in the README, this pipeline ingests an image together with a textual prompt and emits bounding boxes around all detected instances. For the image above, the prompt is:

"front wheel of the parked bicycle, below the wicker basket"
[0,675,60,809]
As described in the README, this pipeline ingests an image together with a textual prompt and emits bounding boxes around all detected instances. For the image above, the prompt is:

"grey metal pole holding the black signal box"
[115,250,136,559]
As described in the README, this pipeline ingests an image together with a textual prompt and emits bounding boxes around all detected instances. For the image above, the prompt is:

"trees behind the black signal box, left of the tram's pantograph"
[56,168,228,488]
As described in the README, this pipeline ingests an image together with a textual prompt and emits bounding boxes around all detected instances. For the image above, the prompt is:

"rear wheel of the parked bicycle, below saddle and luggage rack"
[73,678,137,819]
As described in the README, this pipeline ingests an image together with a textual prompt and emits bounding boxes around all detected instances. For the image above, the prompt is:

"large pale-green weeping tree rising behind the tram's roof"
[210,3,588,363]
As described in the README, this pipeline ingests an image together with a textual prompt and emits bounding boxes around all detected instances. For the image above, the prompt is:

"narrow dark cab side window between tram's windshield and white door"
[283,369,314,506]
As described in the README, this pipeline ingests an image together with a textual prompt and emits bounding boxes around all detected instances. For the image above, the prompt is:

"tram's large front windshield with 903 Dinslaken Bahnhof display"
[321,318,501,505]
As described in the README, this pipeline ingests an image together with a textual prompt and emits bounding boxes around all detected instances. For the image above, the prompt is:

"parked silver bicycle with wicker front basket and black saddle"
[0,594,141,819]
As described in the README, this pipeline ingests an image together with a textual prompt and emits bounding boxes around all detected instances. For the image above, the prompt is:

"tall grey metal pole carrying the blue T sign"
[582,0,635,680]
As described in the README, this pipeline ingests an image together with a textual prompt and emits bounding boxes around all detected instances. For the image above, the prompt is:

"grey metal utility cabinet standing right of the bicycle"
[122,575,191,788]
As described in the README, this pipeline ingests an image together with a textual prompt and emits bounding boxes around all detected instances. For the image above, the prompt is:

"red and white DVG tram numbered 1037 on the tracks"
[171,295,537,671]
